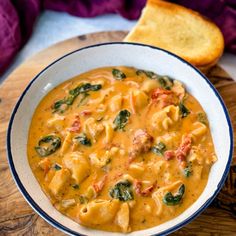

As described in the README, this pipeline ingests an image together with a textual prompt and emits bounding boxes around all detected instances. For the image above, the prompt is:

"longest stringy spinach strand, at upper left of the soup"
[52,83,102,112]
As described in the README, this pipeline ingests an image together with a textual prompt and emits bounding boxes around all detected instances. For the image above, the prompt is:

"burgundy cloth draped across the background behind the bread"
[0,0,236,74]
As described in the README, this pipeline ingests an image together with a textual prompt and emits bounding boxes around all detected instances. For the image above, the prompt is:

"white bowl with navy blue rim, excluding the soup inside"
[7,43,233,236]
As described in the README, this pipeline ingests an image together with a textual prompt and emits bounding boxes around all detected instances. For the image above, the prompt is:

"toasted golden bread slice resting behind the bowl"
[124,0,224,70]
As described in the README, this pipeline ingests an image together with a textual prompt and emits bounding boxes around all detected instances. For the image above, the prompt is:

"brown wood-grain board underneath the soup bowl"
[0,31,236,236]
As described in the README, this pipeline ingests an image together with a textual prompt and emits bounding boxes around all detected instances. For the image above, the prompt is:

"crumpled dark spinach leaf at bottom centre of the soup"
[109,180,134,202]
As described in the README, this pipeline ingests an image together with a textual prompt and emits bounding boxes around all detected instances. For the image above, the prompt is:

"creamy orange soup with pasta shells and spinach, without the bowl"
[28,67,217,233]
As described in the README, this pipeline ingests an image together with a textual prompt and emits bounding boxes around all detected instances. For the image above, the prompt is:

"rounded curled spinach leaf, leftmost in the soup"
[35,135,61,157]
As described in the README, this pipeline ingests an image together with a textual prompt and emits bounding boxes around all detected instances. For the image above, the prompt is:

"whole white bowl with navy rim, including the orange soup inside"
[7,43,233,235]
